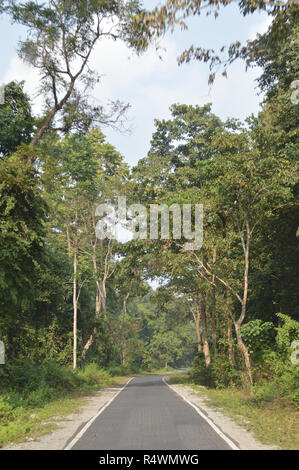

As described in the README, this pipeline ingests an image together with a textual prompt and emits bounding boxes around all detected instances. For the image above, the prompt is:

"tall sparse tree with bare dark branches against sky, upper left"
[6,0,152,163]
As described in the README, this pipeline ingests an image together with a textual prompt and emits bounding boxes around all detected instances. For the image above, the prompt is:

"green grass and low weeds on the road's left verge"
[0,364,127,448]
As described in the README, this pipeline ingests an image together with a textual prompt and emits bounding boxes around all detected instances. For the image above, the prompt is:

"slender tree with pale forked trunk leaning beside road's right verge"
[192,124,294,385]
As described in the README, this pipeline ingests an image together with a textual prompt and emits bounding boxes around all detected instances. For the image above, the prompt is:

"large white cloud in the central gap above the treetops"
[93,35,261,163]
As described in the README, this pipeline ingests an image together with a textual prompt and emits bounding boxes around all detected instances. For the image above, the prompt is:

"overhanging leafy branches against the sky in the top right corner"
[142,0,298,83]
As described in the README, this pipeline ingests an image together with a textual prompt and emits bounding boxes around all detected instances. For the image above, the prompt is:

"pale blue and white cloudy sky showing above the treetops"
[0,1,270,166]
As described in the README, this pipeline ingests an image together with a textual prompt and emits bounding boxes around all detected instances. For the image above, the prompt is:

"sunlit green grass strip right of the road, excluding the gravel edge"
[167,374,299,450]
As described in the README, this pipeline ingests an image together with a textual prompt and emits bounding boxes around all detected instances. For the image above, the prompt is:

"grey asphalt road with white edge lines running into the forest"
[72,375,230,450]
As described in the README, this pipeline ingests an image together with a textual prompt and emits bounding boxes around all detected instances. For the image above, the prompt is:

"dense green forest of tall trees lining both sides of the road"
[0,0,299,448]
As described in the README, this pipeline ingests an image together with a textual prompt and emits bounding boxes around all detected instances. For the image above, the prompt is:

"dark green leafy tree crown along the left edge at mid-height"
[0,150,46,355]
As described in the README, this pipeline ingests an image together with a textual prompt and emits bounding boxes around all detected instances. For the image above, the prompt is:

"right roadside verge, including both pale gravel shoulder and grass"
[167,374,299,450]
